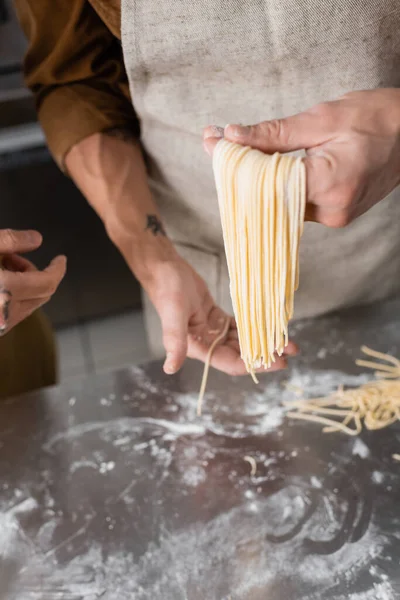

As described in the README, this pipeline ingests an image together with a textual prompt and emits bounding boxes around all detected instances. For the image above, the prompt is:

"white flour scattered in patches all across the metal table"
[0,369,395,600]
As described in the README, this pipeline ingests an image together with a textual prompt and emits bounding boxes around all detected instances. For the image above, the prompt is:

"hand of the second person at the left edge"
[0,229,66,335]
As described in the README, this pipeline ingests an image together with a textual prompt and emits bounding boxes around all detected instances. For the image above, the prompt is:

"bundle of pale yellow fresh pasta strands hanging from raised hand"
[213,140,305,372]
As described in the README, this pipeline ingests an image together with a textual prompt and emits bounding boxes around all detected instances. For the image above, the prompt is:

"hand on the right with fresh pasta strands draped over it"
[204,89,400,227]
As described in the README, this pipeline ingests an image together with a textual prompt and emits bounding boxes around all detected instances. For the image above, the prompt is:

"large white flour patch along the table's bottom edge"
[16,486,395,600]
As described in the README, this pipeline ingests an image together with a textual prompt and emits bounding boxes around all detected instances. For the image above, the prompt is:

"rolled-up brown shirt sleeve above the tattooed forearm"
[14,0,139,168]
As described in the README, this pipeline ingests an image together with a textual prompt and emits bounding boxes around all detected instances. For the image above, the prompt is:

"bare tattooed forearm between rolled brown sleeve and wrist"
[65,131,176,283]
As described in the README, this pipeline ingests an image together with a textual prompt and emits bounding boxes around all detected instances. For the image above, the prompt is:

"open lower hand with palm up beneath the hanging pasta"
[138,256,297,375]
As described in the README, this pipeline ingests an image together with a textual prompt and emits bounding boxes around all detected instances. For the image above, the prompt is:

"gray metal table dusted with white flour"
[0,300,400,600]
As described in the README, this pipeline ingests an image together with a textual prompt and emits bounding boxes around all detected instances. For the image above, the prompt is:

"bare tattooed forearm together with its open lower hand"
[65,133,296,375]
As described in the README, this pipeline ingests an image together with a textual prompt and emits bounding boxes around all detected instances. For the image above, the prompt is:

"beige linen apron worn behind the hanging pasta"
[121,0,400,356]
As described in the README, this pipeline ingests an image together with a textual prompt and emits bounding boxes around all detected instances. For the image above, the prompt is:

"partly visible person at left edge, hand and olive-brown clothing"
[0,229,66,398]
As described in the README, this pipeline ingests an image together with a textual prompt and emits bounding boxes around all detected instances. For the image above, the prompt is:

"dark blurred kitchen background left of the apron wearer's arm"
[0,0,149,380]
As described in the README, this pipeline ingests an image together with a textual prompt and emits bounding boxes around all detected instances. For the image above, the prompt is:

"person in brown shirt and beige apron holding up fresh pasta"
[15,0,400,374]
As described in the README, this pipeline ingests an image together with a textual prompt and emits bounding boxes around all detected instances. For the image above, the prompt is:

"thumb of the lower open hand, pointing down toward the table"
[160,303,188,375]
